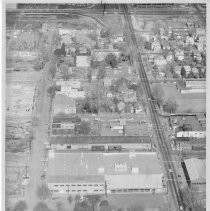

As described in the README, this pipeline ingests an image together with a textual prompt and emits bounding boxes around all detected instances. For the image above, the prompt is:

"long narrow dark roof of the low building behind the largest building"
[51,136,151,144]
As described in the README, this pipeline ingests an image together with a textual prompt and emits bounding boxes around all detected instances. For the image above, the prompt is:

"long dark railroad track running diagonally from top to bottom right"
[122,5,184,210]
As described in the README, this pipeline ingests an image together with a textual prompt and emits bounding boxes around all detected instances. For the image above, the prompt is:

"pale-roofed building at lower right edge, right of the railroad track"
[184,158,206,186]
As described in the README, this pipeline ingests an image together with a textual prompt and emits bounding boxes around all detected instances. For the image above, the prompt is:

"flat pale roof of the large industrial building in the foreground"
[47,151,162,185]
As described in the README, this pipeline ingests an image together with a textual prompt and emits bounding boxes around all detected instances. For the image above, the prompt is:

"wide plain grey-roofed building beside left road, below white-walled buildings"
[54,94,76,115]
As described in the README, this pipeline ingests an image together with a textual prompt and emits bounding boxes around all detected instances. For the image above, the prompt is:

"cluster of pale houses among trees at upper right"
[142,21,206,77]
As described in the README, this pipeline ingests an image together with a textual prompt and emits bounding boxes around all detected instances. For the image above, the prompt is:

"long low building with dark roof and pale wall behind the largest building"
[49,136,153,152]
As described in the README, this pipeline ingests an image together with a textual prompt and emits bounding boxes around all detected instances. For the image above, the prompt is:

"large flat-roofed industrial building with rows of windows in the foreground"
[47,150,165,195]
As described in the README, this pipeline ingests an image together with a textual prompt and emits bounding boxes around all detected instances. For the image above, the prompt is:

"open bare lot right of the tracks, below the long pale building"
[152,83,206,113]
